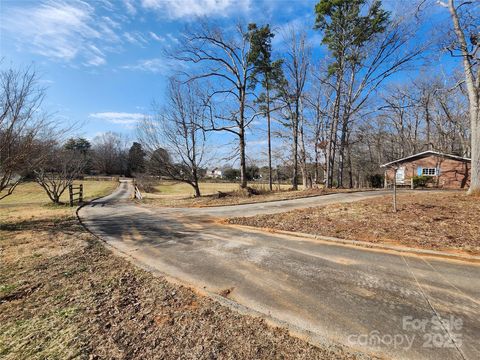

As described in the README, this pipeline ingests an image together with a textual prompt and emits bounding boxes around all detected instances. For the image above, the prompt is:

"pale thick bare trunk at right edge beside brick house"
[442,0,480,194]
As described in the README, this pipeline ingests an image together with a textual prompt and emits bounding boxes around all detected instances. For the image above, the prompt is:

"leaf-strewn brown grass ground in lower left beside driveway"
[0,212,374,359]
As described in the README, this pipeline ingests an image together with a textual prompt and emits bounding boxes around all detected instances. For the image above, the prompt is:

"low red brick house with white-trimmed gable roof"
[381,150,470,189]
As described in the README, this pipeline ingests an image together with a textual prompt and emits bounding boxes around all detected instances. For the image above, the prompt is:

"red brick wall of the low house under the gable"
[387,155,470,189]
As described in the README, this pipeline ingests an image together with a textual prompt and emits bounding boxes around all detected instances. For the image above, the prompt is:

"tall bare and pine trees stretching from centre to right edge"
[139,0,480,194]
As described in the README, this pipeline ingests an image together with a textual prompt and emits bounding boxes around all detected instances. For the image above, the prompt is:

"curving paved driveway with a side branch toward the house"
[80,183,480,359]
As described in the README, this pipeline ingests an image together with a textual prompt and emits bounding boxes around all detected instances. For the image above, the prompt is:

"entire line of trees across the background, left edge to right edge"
[0,0,480,201]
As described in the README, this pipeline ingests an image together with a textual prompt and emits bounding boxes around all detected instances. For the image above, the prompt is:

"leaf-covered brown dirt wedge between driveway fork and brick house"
[227,192,480,254]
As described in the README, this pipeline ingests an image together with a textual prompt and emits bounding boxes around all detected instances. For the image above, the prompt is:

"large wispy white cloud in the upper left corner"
[0,1,124,66]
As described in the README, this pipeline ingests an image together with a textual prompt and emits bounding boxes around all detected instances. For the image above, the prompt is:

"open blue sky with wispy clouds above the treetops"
[0,0,458,165]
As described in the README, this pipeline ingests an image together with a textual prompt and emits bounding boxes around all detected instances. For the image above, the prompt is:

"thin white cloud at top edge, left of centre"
[142,0,251,19]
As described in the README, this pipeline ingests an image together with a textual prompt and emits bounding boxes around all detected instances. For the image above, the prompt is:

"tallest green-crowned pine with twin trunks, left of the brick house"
[315,0,390,187]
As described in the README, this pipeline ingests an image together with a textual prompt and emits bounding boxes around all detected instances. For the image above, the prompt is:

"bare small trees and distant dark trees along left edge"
[0,68,145,204]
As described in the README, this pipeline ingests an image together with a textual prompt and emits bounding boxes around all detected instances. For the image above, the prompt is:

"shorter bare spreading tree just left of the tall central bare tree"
[138,79,206,197]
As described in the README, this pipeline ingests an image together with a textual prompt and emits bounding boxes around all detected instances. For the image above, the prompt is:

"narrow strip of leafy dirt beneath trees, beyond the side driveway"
[143,188,368,207]
